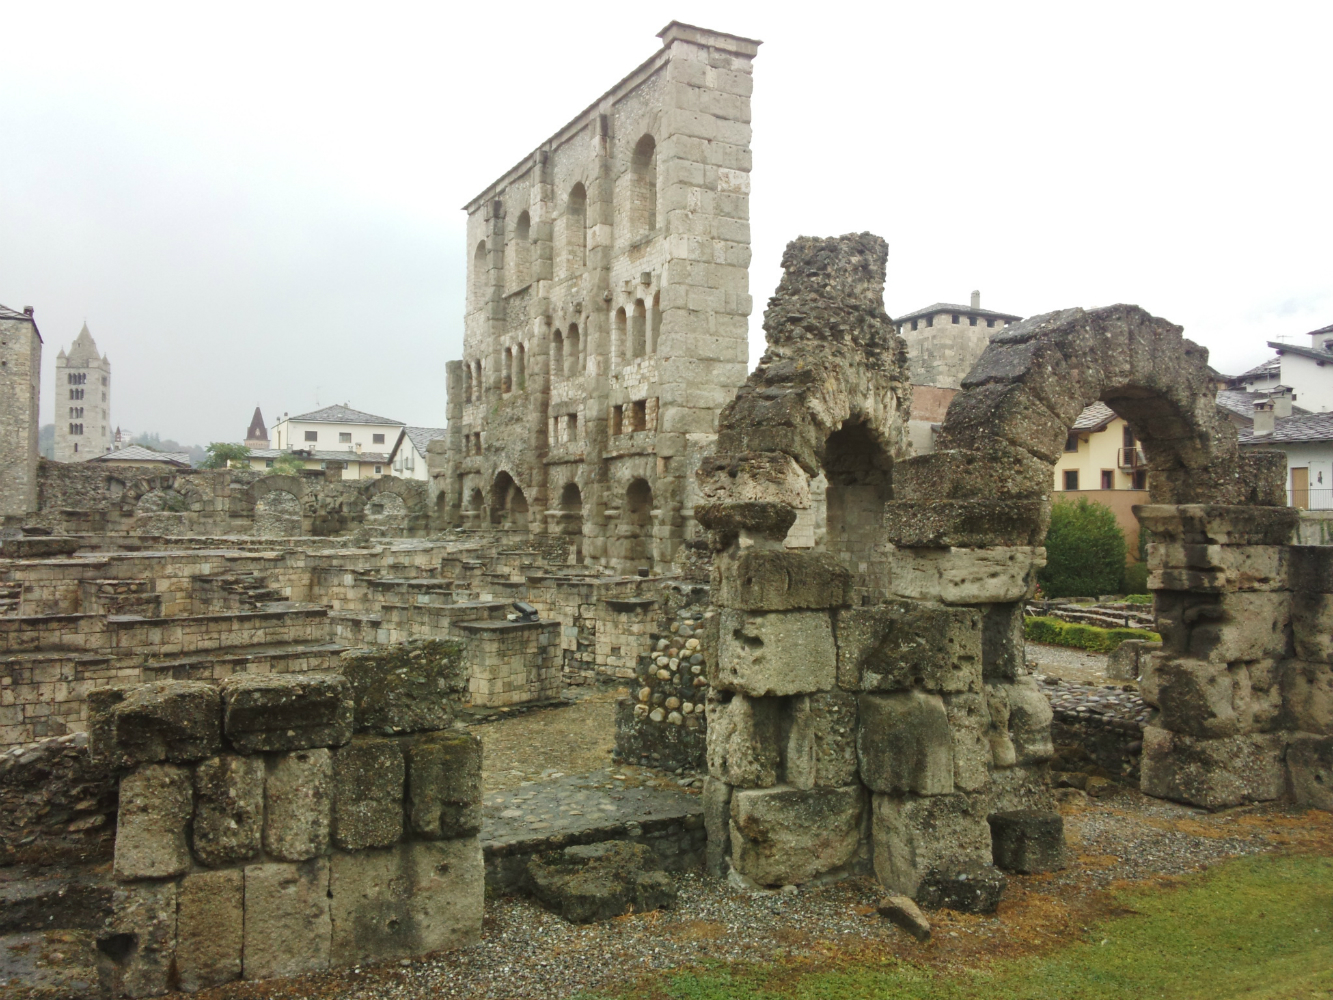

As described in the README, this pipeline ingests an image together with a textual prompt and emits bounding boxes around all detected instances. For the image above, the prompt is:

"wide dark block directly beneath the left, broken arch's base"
[714,549,852,611]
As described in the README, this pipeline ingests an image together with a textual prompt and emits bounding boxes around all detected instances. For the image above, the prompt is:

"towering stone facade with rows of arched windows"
[436,21,760,572]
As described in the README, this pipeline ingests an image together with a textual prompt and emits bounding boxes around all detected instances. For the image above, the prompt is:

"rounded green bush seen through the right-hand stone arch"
[1037,496,1125,597]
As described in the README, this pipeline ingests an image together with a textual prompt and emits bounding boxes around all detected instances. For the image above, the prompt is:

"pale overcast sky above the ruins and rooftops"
[0,0,1333,444]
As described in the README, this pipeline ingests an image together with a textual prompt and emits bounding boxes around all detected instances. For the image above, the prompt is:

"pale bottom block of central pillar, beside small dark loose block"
[872,792,990,897]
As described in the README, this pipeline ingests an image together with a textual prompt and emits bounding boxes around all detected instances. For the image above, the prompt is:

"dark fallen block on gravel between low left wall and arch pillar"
[528,840,676,924]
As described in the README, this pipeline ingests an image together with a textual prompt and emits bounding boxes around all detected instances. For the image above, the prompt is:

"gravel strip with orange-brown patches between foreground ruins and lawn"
[197,789,1333,1000]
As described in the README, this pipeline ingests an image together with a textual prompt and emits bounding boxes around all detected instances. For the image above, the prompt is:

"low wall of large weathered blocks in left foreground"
[84,669,484,997]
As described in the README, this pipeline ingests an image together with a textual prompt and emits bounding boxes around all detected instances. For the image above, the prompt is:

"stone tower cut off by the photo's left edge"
[0,305,41,525]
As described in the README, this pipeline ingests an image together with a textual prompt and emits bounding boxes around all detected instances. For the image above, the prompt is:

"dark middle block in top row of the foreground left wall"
[223,673,353,753]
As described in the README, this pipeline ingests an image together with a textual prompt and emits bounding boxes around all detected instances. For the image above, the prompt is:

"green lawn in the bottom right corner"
[589,855,1333,1000]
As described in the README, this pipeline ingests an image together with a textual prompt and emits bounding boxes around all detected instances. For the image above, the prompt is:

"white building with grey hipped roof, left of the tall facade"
[251,405,405,479]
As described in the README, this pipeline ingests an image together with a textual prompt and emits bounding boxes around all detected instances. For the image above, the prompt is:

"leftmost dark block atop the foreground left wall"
[89,681,223,768]
